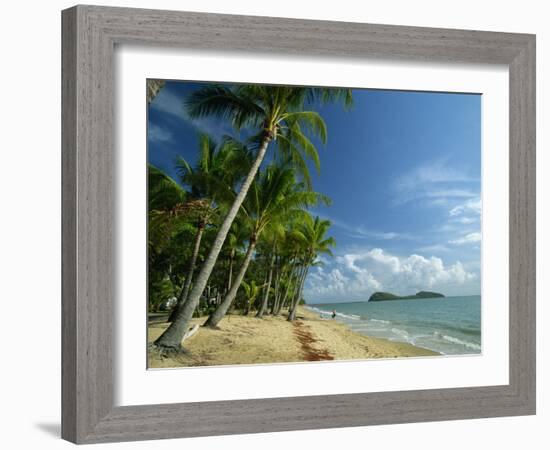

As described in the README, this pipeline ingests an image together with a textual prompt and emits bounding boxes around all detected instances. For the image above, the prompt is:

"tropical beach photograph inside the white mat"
[147,79,483,369]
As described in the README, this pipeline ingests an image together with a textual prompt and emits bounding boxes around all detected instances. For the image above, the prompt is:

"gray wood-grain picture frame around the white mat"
[62,6,535,443]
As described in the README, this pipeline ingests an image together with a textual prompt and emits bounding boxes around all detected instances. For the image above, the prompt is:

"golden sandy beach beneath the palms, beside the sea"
[148,307,438,368]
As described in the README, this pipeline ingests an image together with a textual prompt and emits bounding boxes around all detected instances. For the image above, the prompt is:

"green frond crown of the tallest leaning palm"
[185,84,352,187]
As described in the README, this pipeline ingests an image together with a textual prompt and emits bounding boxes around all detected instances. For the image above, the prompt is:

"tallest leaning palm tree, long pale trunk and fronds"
[155,84,352,351]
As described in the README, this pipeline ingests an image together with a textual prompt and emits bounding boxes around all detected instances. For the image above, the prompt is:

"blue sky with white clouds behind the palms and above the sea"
[148,82,481,302]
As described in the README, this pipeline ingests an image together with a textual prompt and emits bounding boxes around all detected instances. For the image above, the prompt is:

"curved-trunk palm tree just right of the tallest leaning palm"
[204,165,329,328]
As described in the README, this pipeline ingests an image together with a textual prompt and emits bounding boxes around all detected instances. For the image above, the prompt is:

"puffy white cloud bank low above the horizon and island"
[306,248,477,301]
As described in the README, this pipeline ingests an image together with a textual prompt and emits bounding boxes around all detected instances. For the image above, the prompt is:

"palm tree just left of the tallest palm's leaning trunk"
[168,134,247,322]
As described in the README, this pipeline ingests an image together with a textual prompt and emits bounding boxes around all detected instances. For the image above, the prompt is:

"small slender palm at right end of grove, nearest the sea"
[288,214,336,321]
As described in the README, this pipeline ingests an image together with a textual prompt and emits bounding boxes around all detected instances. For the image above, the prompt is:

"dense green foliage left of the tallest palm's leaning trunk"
[148,134,253,312]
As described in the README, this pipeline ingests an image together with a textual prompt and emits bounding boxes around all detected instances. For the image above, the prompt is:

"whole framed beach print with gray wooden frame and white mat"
[62,6,535,443]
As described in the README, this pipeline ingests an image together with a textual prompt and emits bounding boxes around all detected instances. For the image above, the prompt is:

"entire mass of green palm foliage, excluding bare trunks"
[148,84,352,315]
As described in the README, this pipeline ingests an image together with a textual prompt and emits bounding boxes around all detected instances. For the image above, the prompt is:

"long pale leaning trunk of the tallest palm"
[155,134,272,351]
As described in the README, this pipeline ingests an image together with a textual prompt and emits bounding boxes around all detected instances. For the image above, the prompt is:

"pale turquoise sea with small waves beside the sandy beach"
[307,295,481,355]
